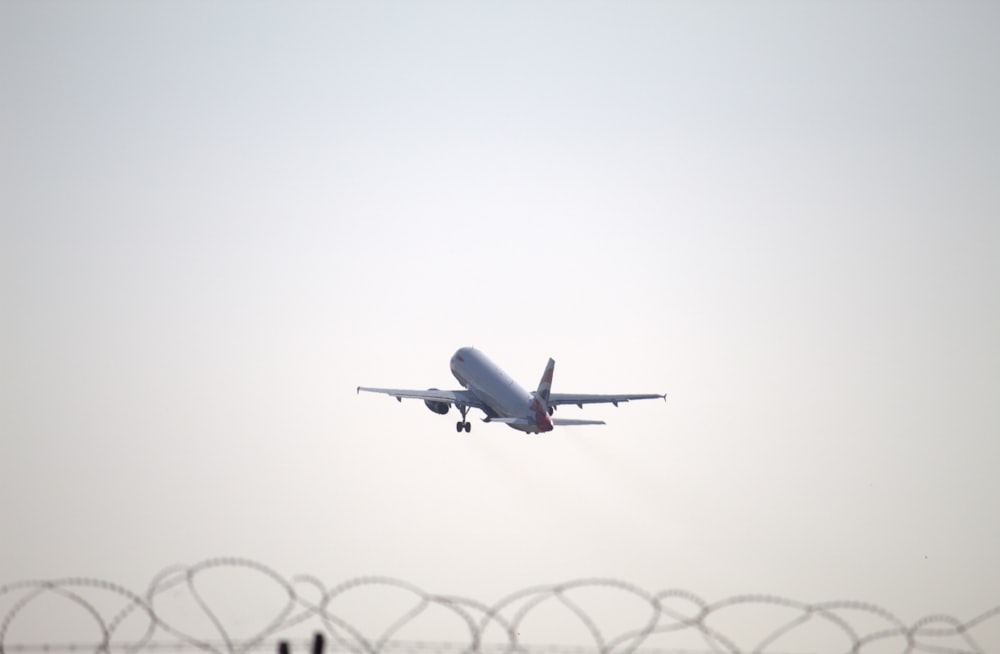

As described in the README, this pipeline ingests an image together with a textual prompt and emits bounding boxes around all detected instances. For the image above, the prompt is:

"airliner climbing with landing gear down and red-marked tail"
[357,347,667,434]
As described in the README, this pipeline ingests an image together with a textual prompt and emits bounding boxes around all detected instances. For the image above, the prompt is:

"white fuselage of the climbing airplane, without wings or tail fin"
[451,347,552,432]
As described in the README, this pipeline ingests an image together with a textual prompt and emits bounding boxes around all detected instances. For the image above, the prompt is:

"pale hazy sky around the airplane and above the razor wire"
[0,1,1000,652]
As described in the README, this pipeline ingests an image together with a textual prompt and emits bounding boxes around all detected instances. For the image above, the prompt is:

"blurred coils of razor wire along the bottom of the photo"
[0,558,1000,654]
